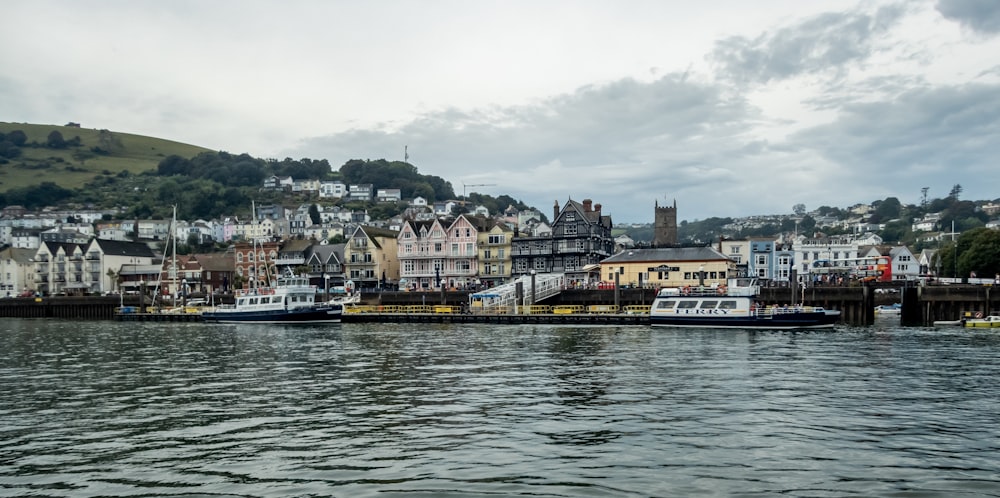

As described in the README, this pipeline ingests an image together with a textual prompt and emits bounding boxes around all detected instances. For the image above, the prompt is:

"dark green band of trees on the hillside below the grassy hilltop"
[0,151,528,220]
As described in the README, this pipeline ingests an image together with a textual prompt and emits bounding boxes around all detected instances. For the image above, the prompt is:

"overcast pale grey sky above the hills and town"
[0,0,1000,224]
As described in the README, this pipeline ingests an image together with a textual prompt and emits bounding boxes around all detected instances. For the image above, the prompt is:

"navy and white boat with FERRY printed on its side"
[649,279,840,329]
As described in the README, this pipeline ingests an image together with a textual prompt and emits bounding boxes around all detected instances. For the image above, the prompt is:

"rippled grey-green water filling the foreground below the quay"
[0,319,1000,497]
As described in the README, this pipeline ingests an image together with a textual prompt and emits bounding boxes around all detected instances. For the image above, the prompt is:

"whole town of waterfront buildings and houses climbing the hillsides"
[0,187,1000,297]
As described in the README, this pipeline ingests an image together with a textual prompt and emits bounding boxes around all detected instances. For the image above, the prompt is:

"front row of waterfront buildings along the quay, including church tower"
[0,199,931,296]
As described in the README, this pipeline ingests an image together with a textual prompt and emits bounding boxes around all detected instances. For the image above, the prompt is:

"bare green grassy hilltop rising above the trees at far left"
[0,122,209,192]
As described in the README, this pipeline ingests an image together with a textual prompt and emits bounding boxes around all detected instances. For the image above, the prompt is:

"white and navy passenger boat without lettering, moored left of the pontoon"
[201,277,344,323]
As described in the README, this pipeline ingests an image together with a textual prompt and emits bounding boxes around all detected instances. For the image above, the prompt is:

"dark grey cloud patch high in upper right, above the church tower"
[709,6,904,83]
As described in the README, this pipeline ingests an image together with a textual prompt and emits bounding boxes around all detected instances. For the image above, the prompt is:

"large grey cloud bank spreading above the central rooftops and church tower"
[284,74,756,220]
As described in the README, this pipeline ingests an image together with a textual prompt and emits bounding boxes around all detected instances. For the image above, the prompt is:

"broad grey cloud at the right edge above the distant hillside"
[791,84,1000,198]
